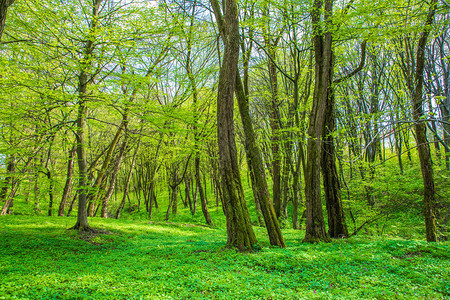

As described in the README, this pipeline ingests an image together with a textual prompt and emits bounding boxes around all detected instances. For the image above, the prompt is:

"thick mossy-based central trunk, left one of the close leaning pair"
[210,0,257,251]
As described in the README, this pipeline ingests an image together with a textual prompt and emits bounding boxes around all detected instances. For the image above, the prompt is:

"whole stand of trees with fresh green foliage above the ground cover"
[0,0,450,251]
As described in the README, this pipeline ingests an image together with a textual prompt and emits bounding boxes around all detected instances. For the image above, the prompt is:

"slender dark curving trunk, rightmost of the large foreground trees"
[412,0,437,242]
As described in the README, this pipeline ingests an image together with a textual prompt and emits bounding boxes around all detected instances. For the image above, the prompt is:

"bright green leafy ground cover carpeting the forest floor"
[0,215,450,299]
